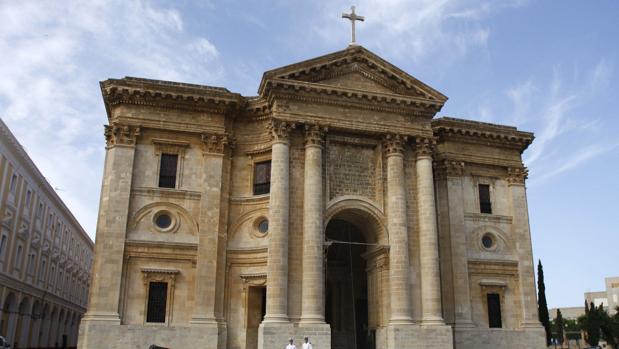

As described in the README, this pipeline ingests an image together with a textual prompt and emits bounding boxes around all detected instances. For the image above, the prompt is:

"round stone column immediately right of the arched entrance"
[383,135,413,325]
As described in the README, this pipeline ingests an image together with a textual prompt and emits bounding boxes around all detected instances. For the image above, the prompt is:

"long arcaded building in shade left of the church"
[0,120,94,348]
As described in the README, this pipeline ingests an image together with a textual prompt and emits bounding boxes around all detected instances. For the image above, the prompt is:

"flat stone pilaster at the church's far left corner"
[81,124,140,324]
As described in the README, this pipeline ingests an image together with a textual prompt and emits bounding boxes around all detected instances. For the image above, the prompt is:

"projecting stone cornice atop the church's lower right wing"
[432,117,534,153]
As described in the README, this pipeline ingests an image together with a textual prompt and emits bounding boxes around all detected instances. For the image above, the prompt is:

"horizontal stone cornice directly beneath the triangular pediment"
[265,79,442,119]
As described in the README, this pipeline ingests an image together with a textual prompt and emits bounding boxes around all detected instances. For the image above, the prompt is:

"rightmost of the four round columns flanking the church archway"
[417,139,444,325]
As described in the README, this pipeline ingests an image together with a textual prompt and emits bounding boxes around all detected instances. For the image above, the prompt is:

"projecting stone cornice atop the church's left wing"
[100,77,245,119]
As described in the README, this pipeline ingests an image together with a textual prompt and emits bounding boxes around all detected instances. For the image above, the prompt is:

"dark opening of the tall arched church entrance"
[325,219,375,349]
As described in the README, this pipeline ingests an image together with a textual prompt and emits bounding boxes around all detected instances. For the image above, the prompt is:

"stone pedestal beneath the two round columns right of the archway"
[387,325,454,349]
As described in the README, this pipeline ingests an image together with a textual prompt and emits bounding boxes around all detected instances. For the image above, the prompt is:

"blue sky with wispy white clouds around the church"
[0,0,619,307]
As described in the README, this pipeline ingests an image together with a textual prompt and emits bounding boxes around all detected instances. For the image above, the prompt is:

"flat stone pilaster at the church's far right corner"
[507,167,541,327]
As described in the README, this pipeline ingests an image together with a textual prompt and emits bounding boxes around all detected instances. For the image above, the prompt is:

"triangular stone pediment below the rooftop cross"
[259,46,447,106]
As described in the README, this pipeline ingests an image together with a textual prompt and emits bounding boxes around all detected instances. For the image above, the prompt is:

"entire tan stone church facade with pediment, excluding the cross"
[78,46,545,349]
